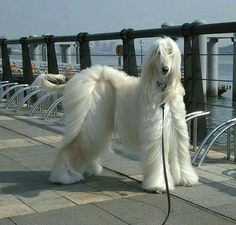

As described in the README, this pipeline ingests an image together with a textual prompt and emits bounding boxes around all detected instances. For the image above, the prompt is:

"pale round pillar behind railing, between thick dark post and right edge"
[207,38,218,97]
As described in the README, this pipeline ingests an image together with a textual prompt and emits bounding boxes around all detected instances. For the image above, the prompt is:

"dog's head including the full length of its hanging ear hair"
[141,37,184,101]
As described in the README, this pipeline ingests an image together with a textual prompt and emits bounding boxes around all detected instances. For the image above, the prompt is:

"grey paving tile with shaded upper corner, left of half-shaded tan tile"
[16,190,75,212]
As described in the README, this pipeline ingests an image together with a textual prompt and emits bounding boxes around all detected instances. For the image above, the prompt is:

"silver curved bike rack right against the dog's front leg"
[185,111,210,151]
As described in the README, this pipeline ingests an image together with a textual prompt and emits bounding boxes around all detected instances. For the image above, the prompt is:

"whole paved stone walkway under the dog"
[0,109,236,225]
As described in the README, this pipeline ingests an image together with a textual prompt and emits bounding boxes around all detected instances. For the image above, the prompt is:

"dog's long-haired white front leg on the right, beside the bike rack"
[170,96,198,186]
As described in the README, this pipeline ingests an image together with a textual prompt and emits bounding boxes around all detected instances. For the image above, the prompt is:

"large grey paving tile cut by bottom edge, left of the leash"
[11,204,127,225]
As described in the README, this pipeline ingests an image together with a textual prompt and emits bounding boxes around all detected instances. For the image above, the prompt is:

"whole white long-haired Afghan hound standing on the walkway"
[33,37,198,192]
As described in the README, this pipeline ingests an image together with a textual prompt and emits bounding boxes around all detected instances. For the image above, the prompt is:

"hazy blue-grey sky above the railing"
[0,0,236,38]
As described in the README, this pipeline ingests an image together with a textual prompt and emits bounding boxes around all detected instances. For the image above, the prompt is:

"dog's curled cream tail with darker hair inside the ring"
[31,74,66,92]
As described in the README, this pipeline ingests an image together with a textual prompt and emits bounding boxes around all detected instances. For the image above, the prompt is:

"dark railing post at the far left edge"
[0,38,12,81]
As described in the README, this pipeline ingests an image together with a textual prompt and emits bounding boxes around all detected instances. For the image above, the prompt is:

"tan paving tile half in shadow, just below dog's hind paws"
[52,183,112,205]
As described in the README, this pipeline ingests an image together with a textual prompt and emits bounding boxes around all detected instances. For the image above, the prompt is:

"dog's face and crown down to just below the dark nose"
[143,37,181,82]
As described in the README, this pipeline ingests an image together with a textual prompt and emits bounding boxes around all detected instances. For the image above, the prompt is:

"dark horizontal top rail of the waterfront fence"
[1,22,236,44]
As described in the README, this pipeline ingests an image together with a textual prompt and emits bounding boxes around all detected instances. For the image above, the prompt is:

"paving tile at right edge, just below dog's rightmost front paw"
[173,182,236,207]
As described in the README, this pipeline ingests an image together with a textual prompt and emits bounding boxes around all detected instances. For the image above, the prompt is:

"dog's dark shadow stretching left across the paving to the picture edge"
[0,171,142,198]
